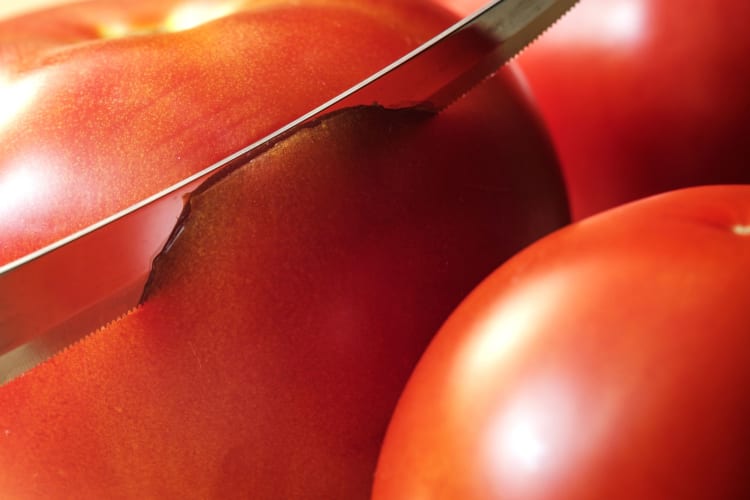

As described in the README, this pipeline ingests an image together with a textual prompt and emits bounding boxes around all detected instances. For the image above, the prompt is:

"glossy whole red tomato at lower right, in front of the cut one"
[374,186,750,500]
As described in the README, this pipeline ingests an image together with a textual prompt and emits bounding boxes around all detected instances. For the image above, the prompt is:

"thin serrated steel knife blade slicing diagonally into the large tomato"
[0,0,578,385]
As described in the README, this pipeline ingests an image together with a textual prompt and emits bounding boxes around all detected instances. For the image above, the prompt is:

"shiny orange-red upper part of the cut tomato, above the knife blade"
[0,0,455,265]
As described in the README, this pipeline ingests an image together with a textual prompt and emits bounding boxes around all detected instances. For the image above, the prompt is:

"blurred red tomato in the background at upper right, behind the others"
[518,0,750,218]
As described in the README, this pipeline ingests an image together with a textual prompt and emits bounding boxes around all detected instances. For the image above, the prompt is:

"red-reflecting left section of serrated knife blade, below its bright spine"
[0,191,187,384]
